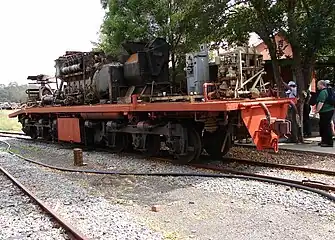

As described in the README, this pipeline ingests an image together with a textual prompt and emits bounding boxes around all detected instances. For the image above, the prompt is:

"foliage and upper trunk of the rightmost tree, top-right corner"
[281,0,335,93]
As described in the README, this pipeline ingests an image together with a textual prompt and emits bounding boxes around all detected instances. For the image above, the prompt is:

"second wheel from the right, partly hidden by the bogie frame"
[175,128,202,164]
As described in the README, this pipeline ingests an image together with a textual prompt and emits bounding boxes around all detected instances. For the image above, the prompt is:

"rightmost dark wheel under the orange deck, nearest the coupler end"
[203,127,232,159]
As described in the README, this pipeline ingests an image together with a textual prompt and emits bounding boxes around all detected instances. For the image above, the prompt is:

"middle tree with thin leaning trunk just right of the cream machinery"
[211,0,283,94]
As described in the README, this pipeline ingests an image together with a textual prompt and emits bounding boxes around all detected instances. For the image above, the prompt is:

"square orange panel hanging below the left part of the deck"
[57,118,81,143]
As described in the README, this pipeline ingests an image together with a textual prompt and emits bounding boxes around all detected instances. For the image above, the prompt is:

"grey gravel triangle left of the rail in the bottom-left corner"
[0,172,69,240]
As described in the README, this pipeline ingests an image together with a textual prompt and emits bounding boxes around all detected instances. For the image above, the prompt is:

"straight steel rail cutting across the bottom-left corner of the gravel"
[0,166,89,240]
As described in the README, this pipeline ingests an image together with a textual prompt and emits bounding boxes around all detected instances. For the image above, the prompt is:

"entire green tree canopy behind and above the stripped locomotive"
[100,0,335,95]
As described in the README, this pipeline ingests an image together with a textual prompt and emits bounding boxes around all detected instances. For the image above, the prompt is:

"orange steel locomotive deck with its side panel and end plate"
[9,96,292,151]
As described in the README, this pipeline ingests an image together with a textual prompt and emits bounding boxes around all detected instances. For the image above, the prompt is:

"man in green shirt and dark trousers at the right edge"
[315,80,334,147]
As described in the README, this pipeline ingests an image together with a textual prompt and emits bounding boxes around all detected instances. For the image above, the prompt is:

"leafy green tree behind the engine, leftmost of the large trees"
[100,0,227,87]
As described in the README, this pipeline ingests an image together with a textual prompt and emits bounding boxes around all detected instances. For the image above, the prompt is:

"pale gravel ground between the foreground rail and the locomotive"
[0,140,335,240]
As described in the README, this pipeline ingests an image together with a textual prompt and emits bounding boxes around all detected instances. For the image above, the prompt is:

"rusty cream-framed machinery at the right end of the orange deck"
[210,47,271,99]
